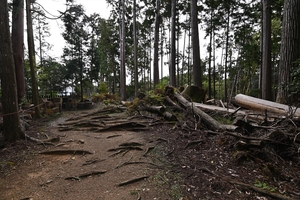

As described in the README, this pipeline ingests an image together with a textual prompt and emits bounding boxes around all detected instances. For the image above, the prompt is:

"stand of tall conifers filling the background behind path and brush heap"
[0,0,300,147]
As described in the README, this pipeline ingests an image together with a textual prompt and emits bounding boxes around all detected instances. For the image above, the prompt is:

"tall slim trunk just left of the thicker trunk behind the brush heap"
[169,0,176,87]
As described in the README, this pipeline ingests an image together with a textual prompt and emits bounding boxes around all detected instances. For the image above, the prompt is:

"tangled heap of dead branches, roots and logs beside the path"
[131,86,300,164]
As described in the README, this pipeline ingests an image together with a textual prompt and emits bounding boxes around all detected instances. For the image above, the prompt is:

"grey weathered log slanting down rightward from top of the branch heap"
[169,86,238,131]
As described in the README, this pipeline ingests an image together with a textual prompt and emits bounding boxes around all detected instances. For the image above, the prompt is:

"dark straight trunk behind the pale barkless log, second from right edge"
[261,0,272,100]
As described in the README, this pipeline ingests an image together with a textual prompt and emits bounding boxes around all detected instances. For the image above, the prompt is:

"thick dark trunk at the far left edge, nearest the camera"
[0,0,21,142]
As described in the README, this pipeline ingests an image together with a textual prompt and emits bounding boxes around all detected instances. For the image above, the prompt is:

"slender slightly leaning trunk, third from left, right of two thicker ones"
[26,0,41,118]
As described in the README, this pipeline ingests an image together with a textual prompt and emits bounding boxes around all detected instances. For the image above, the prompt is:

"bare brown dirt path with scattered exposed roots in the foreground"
[0,109,178,200]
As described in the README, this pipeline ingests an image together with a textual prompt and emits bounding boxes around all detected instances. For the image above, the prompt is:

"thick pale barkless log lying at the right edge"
[234,94,300,117]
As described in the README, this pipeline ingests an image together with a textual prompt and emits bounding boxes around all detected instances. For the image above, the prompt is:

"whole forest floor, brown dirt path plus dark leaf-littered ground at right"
[0,104,300,200]
